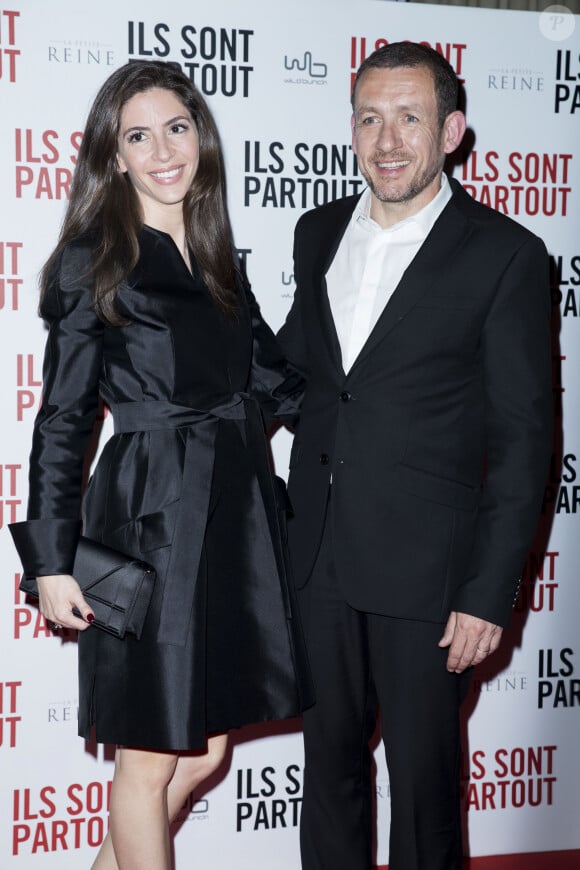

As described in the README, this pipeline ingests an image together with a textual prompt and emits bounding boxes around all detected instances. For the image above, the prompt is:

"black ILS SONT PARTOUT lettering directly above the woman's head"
[127,21,254,97]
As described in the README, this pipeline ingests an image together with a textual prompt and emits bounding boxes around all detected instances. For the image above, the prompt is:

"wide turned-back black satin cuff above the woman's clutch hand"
[9,519,81,577]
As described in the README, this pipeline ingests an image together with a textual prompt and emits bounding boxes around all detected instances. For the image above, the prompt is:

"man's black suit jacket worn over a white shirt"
[279,181,552,625]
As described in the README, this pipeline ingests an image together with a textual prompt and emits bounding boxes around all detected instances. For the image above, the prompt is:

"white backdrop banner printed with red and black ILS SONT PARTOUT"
[0,0,580,870]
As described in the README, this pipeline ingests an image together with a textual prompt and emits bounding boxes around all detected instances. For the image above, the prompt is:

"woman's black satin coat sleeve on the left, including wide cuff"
[10,245,104,576]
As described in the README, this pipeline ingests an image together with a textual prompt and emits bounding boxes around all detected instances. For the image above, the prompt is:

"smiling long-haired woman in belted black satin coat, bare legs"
[9,61,310,870]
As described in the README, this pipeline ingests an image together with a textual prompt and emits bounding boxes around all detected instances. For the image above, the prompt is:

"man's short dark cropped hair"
[350,42,459,127]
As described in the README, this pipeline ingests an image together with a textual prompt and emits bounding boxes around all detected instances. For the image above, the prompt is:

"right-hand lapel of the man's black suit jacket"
[349,187,471,376]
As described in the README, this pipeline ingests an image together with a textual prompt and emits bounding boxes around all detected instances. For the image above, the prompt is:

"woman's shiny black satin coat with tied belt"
[11,227,311,749]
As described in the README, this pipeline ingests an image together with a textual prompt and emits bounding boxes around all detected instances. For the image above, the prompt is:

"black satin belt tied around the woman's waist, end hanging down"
[111,393,271,646]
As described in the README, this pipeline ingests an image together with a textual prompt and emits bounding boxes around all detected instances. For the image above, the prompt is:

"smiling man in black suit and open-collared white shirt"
[280,43,551,870]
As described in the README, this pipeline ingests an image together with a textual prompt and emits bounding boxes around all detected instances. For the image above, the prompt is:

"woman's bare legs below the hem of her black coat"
[92,734,228,870]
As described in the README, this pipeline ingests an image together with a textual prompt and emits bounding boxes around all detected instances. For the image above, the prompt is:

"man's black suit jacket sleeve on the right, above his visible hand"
[451,237,553,625]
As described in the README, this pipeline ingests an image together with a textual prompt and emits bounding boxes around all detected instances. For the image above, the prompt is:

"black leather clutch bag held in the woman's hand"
[20,537,155,638]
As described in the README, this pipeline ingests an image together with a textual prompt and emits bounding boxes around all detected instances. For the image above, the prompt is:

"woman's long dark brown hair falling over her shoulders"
[40,61,235,326]
